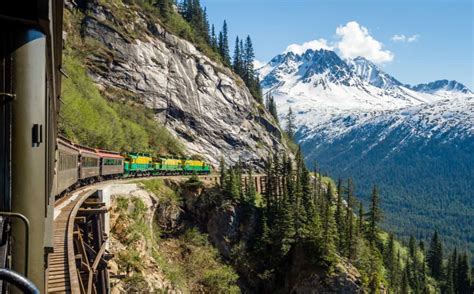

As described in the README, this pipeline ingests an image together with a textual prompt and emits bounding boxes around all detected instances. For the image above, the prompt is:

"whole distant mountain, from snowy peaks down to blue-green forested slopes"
[259,50,474,248]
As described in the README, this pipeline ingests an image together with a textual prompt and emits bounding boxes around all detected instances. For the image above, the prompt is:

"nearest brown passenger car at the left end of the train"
[55,139,79,195]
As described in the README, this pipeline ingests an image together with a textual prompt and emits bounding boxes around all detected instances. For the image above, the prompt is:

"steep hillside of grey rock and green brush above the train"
[62,1,286,168]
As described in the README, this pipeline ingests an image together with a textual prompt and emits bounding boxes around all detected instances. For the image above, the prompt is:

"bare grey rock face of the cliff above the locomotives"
[73,4,285,166]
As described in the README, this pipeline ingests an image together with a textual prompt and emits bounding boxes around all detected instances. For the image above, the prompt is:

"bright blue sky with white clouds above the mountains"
[201,0,474,91]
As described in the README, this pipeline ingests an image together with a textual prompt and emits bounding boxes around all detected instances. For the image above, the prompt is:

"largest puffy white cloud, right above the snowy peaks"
[336,21,394,63]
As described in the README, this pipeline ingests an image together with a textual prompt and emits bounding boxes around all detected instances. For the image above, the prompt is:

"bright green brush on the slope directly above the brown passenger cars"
[59,55,183,154]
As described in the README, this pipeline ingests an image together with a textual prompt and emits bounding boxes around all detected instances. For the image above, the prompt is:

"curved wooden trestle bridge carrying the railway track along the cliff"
[47,175,266,294]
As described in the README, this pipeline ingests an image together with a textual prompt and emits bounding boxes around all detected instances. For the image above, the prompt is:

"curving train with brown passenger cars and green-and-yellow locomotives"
[54,136,211,197]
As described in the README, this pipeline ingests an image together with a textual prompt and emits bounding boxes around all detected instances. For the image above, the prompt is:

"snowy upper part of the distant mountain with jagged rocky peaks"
[259,49,473,136]
